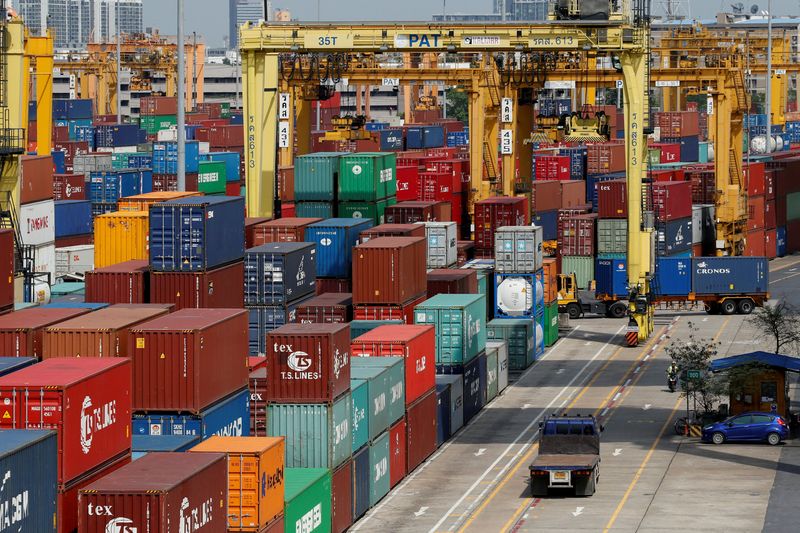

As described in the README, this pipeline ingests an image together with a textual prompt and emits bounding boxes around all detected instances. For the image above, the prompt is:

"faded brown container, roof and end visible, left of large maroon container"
[42,304,172,359]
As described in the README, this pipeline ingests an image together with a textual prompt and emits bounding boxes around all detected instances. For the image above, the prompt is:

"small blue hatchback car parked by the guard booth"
[703,412,789,446]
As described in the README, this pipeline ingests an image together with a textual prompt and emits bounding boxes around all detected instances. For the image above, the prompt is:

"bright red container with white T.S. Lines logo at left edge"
[0,357,131,484]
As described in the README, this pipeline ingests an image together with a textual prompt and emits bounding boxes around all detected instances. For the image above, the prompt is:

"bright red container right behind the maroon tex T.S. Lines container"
[350,325,436,405]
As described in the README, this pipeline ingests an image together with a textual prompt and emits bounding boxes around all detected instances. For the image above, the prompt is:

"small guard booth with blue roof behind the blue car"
[711,352,800,419]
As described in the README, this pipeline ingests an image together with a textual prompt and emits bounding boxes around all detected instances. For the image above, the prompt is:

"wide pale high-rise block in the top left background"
[16,0,144,49]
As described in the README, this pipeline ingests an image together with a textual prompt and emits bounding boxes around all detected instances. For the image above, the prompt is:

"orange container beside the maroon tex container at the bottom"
[190,436,285,531]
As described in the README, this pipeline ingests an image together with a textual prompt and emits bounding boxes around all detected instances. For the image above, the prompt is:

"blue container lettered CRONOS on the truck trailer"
[692,257,769,294]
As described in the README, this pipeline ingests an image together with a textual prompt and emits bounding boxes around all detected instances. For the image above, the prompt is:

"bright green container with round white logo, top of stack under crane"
[340,152,397,202]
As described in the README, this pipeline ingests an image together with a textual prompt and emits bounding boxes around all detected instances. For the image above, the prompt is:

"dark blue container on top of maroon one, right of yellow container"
[150,196,244,272]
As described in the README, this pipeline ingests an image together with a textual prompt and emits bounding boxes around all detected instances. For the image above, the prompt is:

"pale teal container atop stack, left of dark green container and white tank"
[414,294,486,366]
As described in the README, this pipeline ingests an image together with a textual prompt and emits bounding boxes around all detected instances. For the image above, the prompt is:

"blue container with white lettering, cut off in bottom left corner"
[0,429,60,532]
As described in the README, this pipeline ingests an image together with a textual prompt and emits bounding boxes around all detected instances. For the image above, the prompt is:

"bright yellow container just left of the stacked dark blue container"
[94,211,150,268]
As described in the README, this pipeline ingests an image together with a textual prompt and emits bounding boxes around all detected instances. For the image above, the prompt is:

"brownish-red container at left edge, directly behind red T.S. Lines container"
[0,307,90,359]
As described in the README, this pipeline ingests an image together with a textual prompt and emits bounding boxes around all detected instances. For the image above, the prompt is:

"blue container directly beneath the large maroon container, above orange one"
[133,389,250,440]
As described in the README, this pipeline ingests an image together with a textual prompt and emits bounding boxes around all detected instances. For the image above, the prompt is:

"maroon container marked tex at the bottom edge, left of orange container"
[78,452,228,533]
